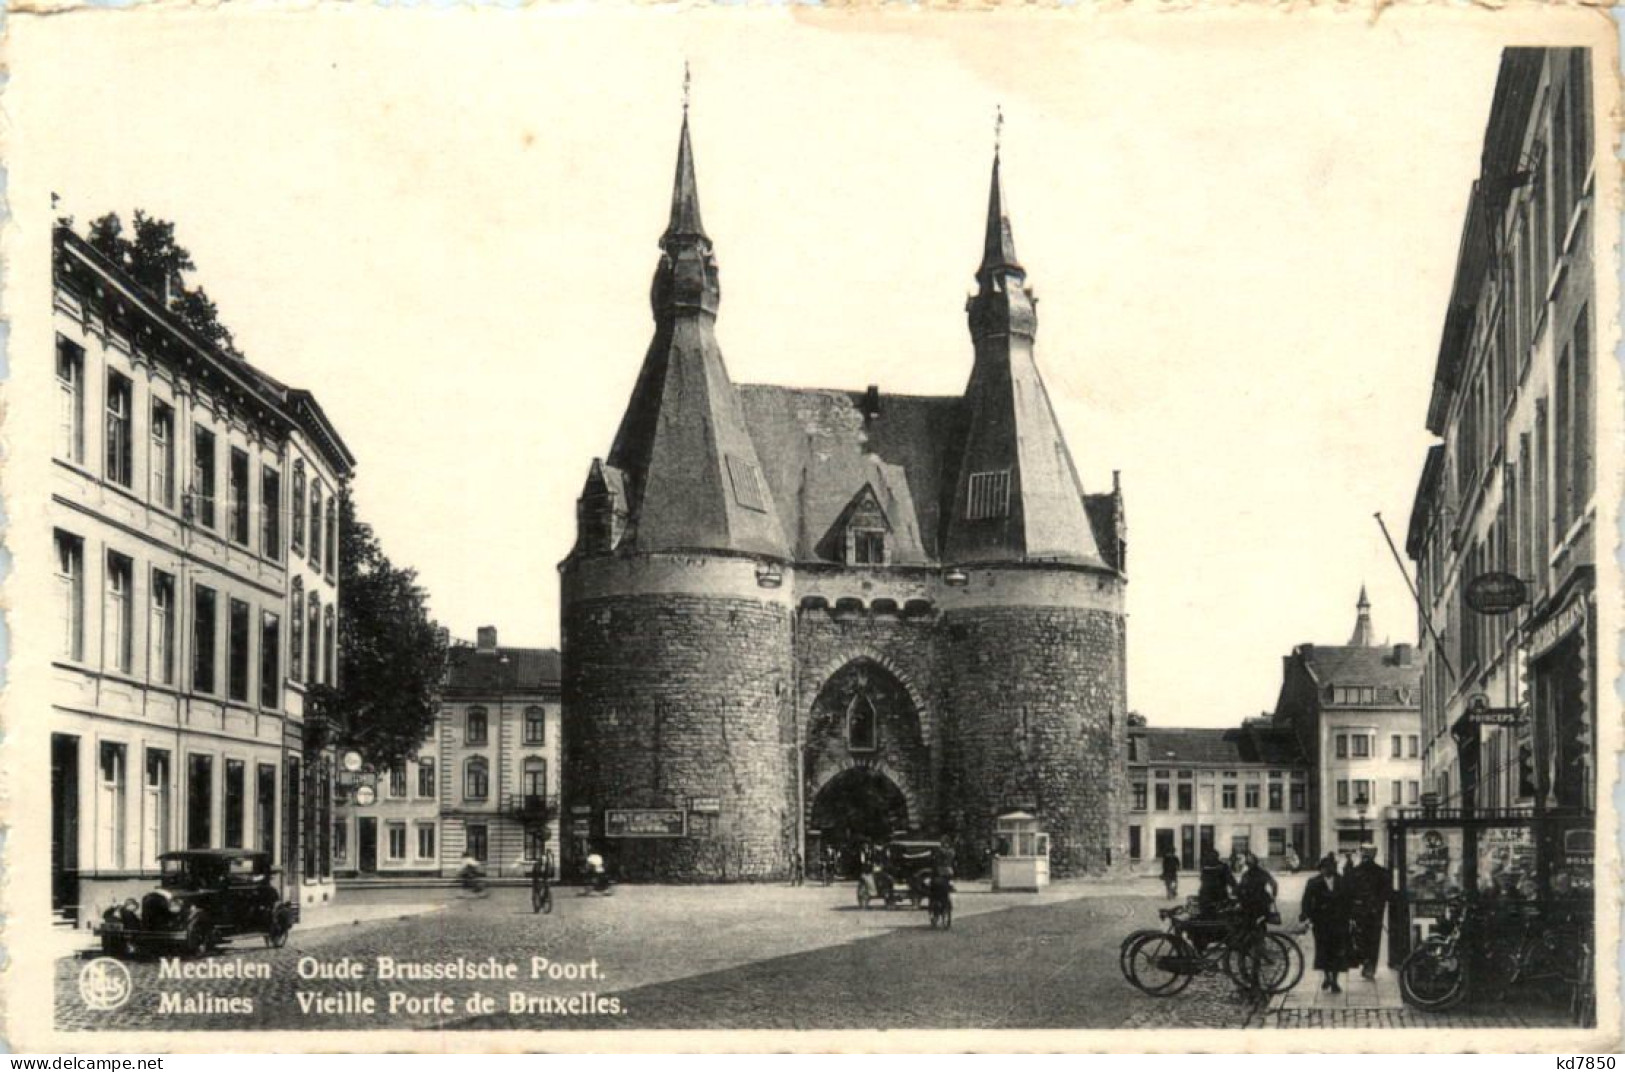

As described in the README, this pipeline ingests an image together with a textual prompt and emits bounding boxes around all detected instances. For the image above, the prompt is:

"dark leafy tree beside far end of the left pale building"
[328,494,445,768]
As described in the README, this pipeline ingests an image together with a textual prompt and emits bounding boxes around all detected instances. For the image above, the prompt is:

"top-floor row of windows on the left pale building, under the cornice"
[57,336,338,580]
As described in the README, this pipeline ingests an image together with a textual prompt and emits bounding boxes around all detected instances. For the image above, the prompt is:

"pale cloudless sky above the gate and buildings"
[7,6,1586,726]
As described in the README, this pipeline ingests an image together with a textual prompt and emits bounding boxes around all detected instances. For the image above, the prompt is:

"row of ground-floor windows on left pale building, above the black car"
[84,741,276,871]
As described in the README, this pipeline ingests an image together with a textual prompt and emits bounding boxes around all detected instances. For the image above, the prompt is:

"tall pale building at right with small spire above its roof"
[1274,588,1422,856]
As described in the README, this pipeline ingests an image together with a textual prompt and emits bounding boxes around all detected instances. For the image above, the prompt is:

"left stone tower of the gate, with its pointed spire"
[561,115,795,880]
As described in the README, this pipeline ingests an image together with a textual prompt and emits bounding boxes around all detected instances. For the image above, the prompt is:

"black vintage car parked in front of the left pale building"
[96,849,299,957]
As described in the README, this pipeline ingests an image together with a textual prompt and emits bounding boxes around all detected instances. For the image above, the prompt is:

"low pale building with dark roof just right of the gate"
[1128,718,1310,874]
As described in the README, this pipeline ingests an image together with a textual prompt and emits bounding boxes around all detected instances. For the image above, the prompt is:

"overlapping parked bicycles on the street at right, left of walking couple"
[1118,903,1303,997]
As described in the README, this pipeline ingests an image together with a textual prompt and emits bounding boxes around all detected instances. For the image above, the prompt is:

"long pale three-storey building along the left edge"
[47,227,354,921]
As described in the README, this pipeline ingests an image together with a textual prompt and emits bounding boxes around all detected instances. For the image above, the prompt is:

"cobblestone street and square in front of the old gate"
[55,882,1579,1030]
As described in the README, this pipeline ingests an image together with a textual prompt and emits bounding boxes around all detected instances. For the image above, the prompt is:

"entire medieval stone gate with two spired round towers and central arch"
[561,119,1126,880]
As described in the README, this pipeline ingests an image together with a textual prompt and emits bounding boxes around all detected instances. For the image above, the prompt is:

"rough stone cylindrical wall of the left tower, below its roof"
[564,594,796,882]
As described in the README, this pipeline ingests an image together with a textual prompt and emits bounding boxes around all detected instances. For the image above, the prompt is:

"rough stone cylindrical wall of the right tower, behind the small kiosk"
[939,597,1126,877]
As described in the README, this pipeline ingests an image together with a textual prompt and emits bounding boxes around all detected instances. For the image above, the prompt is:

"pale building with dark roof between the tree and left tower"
[335,625,561,877]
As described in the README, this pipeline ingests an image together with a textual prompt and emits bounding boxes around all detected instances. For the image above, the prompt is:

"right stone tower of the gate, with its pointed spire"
[941,154,1126,874]
